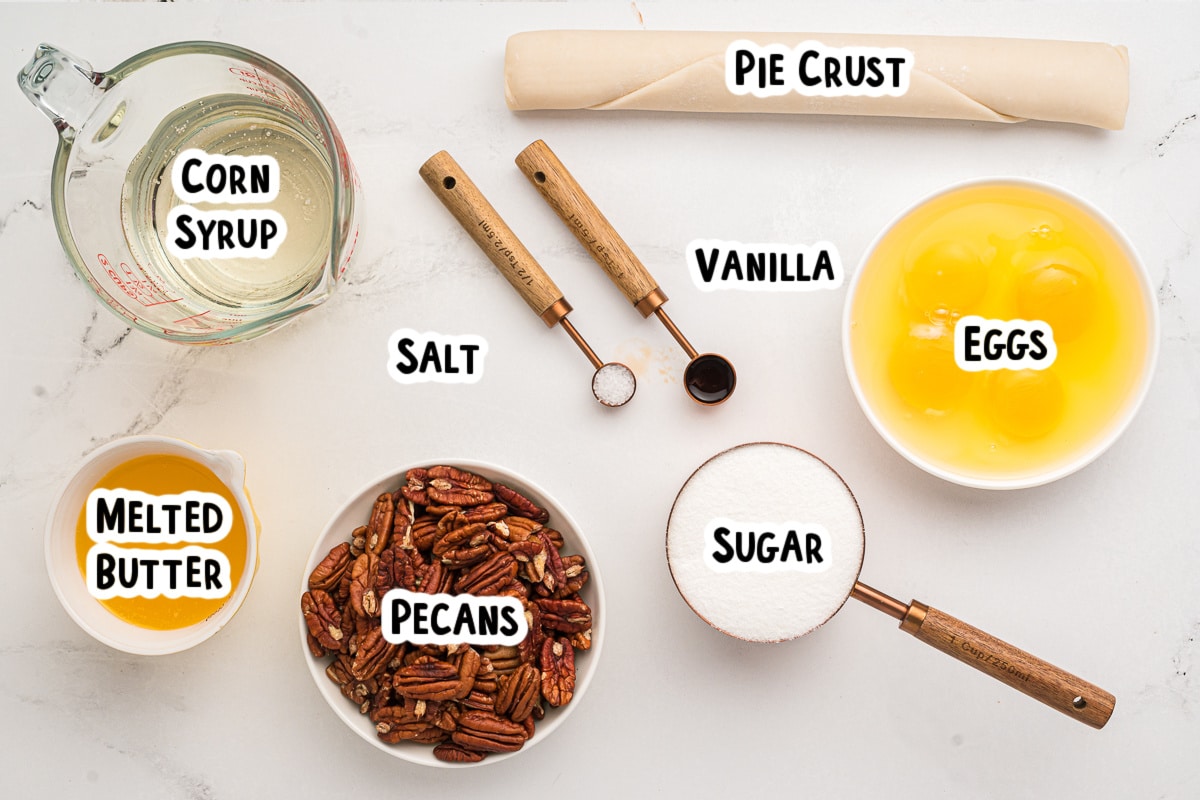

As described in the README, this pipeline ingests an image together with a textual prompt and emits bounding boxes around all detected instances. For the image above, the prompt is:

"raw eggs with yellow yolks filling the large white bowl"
[850,185,1150,480]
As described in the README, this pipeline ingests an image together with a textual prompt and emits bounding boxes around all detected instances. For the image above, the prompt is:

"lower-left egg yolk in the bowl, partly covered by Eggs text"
[888,324,974,413]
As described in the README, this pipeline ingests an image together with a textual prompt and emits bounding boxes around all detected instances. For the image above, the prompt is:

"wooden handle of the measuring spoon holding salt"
[420,150,571,327]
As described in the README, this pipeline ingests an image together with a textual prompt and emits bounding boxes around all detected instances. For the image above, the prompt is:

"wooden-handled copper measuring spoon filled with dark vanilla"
[516,139,738,405]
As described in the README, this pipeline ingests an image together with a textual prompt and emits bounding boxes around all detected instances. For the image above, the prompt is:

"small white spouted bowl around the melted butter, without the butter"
[46,435,259,656]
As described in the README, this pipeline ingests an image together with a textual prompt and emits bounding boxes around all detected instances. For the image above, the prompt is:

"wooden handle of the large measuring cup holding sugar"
[900,600,1116,728]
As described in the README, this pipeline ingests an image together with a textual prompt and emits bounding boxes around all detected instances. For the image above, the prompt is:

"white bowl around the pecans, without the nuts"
[295,458,605,768]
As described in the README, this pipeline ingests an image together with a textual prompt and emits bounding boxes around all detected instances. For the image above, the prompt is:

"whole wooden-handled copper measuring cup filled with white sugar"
[667,441,1116,728]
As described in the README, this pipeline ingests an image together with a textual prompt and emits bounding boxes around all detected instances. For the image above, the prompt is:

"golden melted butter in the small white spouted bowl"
[76,455,247,631]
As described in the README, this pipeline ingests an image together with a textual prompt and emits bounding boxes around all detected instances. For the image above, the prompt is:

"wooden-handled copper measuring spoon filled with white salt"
[420,150,637,408]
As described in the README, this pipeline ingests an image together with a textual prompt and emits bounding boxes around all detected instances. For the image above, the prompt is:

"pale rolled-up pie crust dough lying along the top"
[504,30,1129,130]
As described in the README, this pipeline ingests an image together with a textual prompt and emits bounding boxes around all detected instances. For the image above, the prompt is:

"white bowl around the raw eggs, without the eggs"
[841,178,1159,489]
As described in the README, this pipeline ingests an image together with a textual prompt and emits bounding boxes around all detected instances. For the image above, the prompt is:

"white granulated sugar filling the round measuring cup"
[667,443,865,642]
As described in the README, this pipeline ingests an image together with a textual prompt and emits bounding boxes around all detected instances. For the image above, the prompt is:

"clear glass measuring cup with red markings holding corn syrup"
[17,42,360,344]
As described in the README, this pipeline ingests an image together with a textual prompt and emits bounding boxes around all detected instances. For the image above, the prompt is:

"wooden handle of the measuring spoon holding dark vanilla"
[516,139,667,317]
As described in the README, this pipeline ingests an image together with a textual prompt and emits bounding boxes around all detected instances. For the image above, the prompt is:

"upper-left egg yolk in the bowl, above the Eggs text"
[904,241,988,317]
